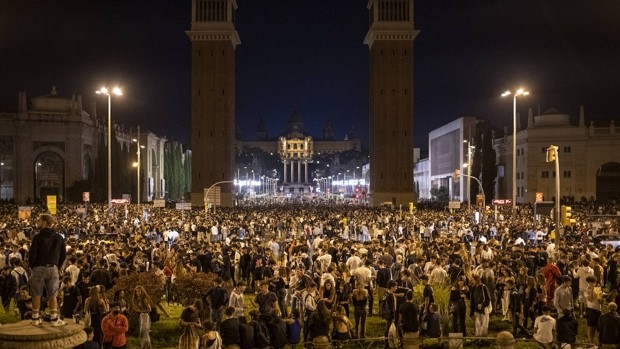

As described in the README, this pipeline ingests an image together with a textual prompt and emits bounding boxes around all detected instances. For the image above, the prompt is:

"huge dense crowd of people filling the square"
[0,200,620,349]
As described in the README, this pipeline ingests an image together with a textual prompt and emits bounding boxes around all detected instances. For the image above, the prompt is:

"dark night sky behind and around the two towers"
[0,0,620,148]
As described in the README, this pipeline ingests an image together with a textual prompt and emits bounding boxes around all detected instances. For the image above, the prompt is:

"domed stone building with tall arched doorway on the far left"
[0,87,166,204]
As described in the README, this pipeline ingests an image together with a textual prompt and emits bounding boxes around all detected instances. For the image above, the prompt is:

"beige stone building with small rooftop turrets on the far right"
[493,107,620,203]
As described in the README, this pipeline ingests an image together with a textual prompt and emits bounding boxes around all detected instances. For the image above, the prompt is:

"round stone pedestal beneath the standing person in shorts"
[0,320,86,349]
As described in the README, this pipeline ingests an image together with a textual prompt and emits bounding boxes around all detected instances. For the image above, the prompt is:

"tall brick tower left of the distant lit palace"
[186,0,241,206]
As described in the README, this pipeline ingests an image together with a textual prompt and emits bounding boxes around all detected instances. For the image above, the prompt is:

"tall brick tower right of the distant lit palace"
[364,0,418,206]
